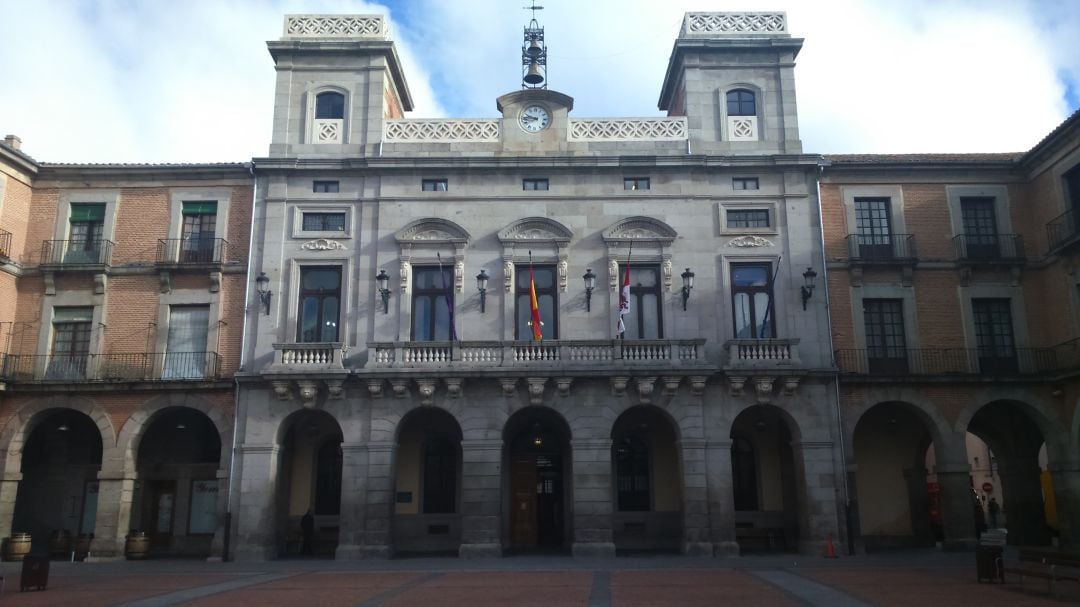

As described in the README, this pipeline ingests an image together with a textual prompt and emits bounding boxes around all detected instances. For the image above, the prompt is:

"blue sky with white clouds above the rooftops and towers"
[0,0,1080,162]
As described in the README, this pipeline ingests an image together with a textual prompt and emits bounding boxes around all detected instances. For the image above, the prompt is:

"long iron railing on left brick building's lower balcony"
[0,352,220,383]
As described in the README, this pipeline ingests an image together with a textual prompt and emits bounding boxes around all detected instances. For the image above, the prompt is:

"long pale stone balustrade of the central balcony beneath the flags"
[367,339,705,368]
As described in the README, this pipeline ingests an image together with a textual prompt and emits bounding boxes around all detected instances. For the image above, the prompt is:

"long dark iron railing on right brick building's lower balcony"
[836,347,1065,376]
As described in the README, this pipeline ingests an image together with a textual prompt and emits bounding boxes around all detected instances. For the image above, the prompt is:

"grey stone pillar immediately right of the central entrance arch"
[570,439,615,556]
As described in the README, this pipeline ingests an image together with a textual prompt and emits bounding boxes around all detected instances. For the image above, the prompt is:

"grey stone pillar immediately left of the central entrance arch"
[458,439,502,558]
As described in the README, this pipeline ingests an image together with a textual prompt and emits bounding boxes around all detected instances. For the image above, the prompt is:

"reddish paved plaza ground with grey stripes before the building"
[0,551,1080,607]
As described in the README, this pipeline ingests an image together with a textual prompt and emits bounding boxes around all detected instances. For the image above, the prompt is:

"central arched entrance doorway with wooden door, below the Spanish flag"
[507,408,570,552]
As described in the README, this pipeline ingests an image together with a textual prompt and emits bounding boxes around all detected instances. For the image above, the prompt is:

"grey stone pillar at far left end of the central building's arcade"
[230,444,281,561]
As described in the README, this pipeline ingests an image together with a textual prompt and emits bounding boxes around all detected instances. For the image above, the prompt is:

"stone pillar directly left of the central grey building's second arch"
[361,442,397,558]
